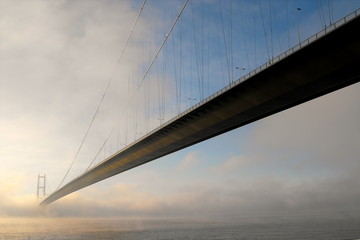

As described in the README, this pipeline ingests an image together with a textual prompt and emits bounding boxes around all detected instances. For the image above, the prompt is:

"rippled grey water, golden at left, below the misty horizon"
[0,217,360,240]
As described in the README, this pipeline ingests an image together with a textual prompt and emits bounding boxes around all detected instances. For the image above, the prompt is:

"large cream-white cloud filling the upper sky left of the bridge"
[0,0,163,185]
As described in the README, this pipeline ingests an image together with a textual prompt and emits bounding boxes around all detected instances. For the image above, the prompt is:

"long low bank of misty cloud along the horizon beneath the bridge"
[39,172,360,217]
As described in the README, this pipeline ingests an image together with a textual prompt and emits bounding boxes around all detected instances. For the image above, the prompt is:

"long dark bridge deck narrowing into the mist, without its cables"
[40,10,360,206]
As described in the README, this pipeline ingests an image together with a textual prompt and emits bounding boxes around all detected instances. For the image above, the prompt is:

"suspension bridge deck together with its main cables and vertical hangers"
[40,1,360,205]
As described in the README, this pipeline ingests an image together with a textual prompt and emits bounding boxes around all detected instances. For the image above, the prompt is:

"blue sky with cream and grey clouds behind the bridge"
[0,0,360,217]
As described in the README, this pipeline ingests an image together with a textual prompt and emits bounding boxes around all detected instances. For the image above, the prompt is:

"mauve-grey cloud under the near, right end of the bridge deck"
[246,84,360,174]
